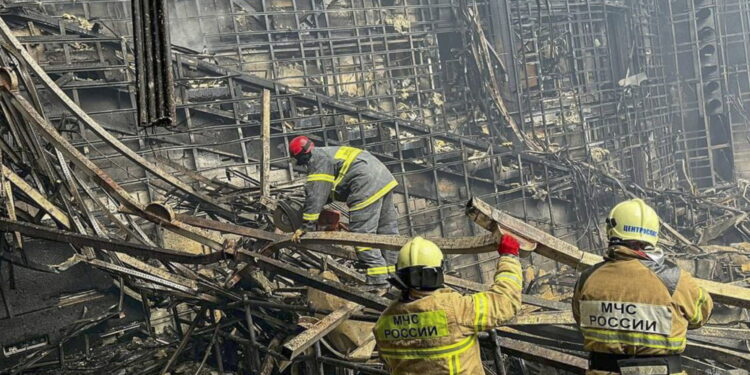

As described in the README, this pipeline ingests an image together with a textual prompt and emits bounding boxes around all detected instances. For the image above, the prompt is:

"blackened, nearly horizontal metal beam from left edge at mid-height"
[0,219,225,264]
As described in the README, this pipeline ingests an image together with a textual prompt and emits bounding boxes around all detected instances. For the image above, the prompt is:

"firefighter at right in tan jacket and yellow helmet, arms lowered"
[573,199,713,375]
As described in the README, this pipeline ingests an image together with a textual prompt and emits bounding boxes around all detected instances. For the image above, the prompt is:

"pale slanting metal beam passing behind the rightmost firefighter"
[467,198,750,308]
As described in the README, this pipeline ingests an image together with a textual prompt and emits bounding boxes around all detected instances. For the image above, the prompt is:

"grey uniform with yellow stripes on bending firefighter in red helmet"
[302,146,398,284]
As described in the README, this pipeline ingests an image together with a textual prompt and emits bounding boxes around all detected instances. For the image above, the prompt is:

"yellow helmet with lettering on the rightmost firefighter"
[607,198,659,246]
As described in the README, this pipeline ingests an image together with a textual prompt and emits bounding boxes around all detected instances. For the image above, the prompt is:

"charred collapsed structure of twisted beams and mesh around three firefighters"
[0,0,750,374]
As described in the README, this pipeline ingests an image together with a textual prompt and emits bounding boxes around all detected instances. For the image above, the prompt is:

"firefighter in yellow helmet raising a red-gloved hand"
[373,235,523,375]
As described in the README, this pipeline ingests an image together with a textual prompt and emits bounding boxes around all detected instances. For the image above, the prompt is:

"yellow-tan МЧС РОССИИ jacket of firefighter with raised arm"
[373,256,523,375]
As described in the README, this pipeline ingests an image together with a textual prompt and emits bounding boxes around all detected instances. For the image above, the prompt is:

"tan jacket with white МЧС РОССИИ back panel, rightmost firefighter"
[573,246,713,355]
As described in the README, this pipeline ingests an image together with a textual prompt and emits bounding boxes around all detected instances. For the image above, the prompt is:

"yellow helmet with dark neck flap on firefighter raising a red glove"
[396,237,443,290]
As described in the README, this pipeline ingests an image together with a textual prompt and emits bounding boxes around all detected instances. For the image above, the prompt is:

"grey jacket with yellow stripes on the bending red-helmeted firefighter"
[302,146,398,230]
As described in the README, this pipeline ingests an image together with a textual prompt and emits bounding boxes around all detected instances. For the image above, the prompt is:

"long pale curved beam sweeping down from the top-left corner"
[0,19,235,218]
